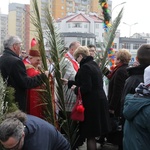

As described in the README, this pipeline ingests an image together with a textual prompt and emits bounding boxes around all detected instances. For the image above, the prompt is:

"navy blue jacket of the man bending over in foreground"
[23,115,70,150]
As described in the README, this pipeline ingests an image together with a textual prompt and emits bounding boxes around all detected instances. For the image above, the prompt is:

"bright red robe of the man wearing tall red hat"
[23,59,43,118]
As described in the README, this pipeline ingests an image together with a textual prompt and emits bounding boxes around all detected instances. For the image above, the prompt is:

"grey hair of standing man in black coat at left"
[3,36,22,48]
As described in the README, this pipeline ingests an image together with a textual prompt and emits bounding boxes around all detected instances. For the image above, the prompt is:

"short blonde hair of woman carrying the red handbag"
[73,46,90,59]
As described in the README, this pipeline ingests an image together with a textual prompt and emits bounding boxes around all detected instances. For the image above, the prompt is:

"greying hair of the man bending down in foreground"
[0,118,24,142]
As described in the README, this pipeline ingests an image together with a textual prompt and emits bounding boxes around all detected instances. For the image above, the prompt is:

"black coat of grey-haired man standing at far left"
[0,49,45,111]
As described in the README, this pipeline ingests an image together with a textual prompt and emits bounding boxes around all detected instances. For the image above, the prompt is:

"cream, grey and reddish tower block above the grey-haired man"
[8,3,30,51]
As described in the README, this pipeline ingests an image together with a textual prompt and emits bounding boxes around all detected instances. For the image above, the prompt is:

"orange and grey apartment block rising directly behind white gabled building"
[51,0,102,19]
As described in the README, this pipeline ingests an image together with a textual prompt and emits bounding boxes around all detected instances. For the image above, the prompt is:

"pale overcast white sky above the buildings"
[0,0,150,37]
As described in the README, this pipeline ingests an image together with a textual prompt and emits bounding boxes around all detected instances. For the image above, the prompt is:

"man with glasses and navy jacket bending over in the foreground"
[0,111,70,150]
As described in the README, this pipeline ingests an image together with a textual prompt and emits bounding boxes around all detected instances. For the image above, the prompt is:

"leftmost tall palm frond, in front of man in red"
[30,0,56,126]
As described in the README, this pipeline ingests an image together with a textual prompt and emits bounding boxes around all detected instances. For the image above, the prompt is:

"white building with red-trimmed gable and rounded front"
[56,13,104,47]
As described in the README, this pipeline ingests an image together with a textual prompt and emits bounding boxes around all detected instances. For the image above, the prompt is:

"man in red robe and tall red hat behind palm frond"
[23,44,44,118]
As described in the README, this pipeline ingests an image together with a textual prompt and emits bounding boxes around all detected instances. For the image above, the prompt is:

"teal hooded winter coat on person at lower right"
[123,94,150,150]
